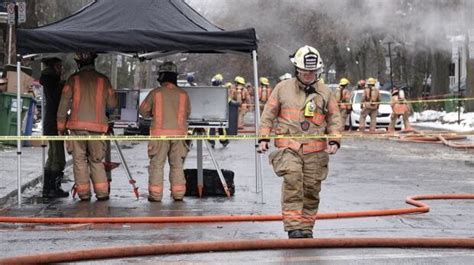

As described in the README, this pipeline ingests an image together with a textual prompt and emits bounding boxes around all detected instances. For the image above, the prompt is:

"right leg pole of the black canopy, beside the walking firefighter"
[252,50,264,204]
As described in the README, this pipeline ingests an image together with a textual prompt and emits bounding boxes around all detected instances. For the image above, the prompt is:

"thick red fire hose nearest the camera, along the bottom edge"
[0,238,474,265]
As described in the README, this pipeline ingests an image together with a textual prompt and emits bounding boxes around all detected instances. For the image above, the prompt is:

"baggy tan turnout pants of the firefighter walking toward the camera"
[270,148,329,231]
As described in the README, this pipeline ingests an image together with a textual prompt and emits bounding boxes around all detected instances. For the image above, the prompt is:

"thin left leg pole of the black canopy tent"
[16,55,23,208]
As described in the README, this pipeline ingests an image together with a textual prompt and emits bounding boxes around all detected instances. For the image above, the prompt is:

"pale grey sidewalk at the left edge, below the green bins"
[0,145,71,207]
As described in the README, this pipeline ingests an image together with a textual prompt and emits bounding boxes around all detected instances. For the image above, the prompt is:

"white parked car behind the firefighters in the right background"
[346,90,402,130]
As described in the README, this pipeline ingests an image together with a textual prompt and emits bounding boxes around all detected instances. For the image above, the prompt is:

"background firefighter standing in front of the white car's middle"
[359,77,380,132]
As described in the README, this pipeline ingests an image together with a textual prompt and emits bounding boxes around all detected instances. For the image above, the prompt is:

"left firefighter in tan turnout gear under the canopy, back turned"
[57,52,117,201]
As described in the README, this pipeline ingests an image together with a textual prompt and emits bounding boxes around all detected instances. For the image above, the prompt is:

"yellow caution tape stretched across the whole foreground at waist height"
[0,131,474,141]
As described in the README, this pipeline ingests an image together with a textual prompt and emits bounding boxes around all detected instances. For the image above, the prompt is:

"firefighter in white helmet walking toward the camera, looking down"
[258,46,342,238]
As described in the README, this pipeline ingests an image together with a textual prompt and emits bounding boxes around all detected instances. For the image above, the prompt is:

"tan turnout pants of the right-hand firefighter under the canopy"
[148,140,188,201]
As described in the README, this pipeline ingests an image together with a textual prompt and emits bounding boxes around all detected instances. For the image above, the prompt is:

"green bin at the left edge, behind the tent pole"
[0,92,33,144]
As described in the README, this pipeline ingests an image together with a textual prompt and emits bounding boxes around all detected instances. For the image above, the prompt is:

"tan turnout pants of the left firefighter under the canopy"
[71,130,109,199]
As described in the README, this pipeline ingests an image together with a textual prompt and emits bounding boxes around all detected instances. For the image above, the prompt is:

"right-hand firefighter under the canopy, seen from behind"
[140,62,191,202]
